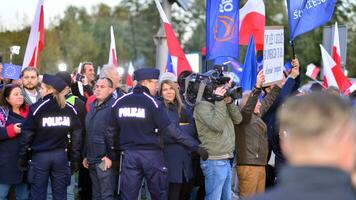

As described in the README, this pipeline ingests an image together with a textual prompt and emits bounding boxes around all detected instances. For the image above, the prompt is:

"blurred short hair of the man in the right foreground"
[278,94,355,140]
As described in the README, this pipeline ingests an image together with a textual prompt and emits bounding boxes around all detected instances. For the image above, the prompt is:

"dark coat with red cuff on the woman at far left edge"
[0,107,28,184]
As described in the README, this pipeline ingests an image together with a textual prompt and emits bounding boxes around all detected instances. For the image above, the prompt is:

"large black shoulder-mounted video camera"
[184,65,242,106]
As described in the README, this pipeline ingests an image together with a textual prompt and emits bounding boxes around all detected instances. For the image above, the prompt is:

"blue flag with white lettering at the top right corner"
[287,0,336,40]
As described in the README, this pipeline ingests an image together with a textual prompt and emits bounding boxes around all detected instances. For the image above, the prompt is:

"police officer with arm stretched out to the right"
[106,68,208,200]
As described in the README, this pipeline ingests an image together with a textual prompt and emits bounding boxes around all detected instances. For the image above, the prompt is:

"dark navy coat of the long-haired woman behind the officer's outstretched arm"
[163,104,197,183]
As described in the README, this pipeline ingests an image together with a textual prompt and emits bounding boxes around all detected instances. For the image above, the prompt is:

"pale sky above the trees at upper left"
[0,0,120,31]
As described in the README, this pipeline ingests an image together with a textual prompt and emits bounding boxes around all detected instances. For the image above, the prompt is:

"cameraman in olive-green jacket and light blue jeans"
[194,83,242,200]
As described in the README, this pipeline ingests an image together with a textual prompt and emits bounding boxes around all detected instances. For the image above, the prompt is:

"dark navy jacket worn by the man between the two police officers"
[84,95,115,164]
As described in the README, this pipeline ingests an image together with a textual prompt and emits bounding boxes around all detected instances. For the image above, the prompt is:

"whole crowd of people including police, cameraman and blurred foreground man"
[0,59,356,200]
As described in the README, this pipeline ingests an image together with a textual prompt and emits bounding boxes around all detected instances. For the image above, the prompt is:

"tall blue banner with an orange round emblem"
[206,0,239,64]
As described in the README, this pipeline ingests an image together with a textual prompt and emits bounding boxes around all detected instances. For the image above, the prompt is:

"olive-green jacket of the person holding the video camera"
[194,101,242,160]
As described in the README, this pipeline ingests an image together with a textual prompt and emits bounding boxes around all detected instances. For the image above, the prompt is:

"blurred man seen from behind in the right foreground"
[248,94,356,200]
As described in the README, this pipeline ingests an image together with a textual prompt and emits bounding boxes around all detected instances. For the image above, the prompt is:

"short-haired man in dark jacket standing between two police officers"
[83,78,115,200]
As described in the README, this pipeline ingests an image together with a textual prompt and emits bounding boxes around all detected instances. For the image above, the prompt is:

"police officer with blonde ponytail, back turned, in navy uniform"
[18,74,82,200]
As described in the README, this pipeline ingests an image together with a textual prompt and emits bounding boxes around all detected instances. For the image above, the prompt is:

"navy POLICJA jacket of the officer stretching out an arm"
[106,85,199,156]
